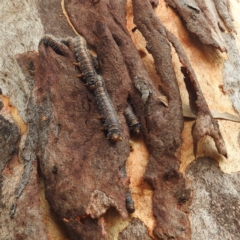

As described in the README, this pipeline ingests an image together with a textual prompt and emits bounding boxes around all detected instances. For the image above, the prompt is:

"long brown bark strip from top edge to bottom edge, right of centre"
[133,0,190,239]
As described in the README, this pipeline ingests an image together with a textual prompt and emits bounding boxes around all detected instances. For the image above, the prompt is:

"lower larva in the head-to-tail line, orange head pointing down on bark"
[94,75,121,142]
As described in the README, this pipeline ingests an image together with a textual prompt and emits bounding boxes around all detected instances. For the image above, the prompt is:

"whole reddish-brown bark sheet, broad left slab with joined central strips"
[12,1,227,239]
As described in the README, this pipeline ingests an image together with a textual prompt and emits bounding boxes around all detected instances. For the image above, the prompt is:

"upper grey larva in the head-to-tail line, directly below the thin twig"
[74,36,97,90]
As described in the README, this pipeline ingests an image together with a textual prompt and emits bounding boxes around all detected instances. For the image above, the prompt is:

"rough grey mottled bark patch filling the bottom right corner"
[187,158,240,240]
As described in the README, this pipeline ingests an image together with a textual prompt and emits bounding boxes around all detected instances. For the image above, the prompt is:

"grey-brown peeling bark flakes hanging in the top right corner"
[165,0,236,52]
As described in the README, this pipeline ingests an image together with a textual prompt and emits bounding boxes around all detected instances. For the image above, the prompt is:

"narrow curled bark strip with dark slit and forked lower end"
[165,30,227,157]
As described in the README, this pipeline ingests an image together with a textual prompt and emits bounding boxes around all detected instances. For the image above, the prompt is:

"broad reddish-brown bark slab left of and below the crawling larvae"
[19,45,129,239]
